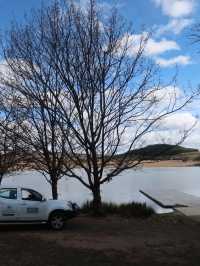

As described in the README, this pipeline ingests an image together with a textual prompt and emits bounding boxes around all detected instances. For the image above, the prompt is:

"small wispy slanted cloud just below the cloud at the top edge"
[156,18,194,35]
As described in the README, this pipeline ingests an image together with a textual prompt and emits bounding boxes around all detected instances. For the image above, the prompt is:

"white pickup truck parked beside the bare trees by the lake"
[0,187,78,230]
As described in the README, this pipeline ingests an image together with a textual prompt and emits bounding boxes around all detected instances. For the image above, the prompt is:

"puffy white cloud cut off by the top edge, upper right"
[152,0,196,18]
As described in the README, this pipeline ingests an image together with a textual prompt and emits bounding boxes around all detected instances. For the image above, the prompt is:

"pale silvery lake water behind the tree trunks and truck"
[2,167,200,212]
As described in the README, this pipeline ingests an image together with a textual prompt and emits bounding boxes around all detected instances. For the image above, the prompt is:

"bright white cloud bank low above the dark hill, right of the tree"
[115,86,200,152]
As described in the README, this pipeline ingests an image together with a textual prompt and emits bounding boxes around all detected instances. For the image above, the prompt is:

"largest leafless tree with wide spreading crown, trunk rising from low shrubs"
[2,0,195,212]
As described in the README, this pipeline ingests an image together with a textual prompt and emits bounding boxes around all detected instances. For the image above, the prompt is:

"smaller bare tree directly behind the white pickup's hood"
[14,89,69,199]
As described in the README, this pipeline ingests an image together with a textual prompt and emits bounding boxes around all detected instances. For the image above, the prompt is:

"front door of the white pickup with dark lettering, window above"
[19,188,47,221]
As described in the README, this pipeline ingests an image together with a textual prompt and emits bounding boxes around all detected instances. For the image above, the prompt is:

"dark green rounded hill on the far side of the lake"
[116,144,200,160]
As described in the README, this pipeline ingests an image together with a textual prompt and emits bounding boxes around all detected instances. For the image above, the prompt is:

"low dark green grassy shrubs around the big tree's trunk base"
[81,201,155,218]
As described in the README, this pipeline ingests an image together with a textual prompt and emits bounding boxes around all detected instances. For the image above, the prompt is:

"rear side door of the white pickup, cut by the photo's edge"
[0,188,18,222]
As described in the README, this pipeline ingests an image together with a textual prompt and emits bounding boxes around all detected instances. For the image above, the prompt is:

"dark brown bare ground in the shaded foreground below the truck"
[0,214,200,266]
